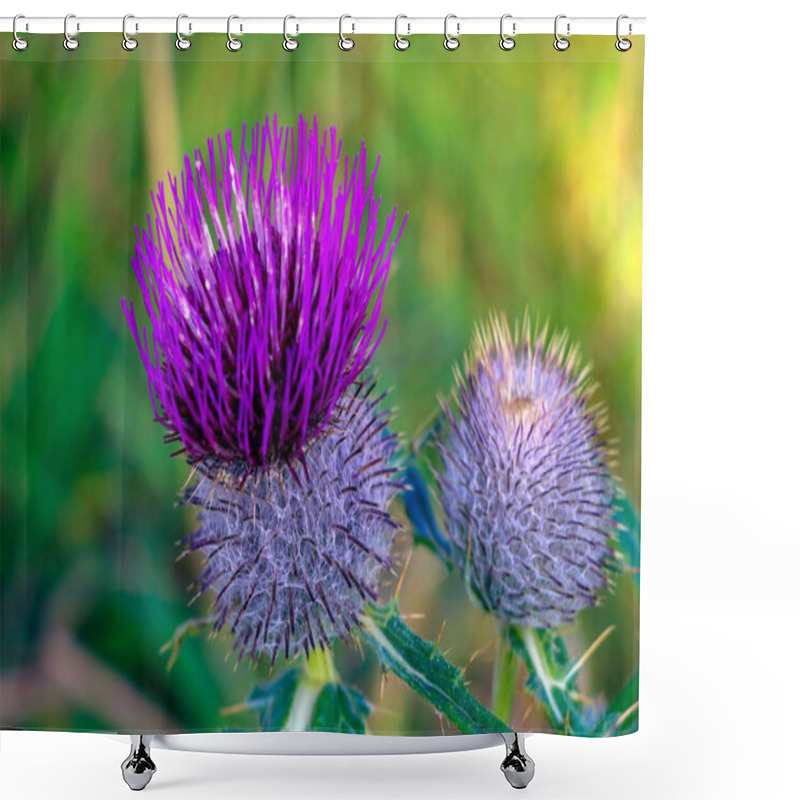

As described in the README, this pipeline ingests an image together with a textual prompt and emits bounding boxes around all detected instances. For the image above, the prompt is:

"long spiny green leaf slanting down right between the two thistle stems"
[362,603,510,733]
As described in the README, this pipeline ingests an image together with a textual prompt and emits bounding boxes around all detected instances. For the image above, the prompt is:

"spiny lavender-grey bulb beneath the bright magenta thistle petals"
[184,383,401,663]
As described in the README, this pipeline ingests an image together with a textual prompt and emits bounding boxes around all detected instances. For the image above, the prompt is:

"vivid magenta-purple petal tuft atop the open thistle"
[122,116,404,474]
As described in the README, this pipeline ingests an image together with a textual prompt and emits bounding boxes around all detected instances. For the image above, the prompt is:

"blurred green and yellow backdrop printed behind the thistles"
[0,35,644,733]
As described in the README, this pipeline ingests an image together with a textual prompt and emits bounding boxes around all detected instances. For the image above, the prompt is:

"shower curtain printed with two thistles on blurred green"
[0,29,644,736]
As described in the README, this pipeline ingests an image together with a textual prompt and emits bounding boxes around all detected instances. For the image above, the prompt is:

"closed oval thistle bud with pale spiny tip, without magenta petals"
[436,318,616,628]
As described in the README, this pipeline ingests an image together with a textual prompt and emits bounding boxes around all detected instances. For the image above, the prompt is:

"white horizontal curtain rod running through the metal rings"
[0,14,645,36]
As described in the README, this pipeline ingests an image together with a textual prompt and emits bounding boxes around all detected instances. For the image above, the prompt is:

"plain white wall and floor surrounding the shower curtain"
[0,0,800,800]
